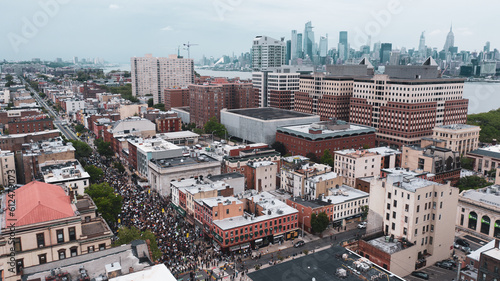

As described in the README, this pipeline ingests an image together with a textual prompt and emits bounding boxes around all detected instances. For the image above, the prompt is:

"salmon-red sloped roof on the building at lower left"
[15,181,75,226]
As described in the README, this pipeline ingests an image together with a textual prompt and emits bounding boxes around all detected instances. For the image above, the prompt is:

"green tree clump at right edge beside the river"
[467,108,500,143]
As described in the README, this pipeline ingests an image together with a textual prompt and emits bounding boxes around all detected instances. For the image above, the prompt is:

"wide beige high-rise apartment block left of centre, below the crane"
[130,54,194,104]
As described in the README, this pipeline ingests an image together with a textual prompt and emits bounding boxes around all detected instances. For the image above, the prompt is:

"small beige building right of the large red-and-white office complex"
[432,124,481,155]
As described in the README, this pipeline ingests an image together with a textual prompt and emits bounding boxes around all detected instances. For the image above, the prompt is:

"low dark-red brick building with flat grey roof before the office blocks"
[276,120,376,158]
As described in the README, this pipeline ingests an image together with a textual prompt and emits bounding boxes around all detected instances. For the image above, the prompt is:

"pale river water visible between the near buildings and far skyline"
[104,63,500,114]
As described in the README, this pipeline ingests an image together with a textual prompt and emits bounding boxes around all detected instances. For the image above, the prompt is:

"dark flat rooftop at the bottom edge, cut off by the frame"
[248,246,404,281]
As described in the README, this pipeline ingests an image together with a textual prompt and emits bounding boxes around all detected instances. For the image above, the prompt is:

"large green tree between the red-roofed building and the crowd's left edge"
[85,182,123,225]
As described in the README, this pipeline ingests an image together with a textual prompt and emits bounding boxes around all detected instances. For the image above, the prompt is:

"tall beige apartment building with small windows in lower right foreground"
[359,174,459,276]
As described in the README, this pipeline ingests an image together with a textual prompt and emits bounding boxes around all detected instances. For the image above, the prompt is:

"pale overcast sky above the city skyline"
[0,0,500,62]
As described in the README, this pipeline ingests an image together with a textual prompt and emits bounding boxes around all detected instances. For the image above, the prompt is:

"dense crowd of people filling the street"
[83,143,236,276]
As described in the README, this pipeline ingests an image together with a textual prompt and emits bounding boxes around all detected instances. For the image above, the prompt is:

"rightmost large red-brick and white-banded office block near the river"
[349,71,468,147]
